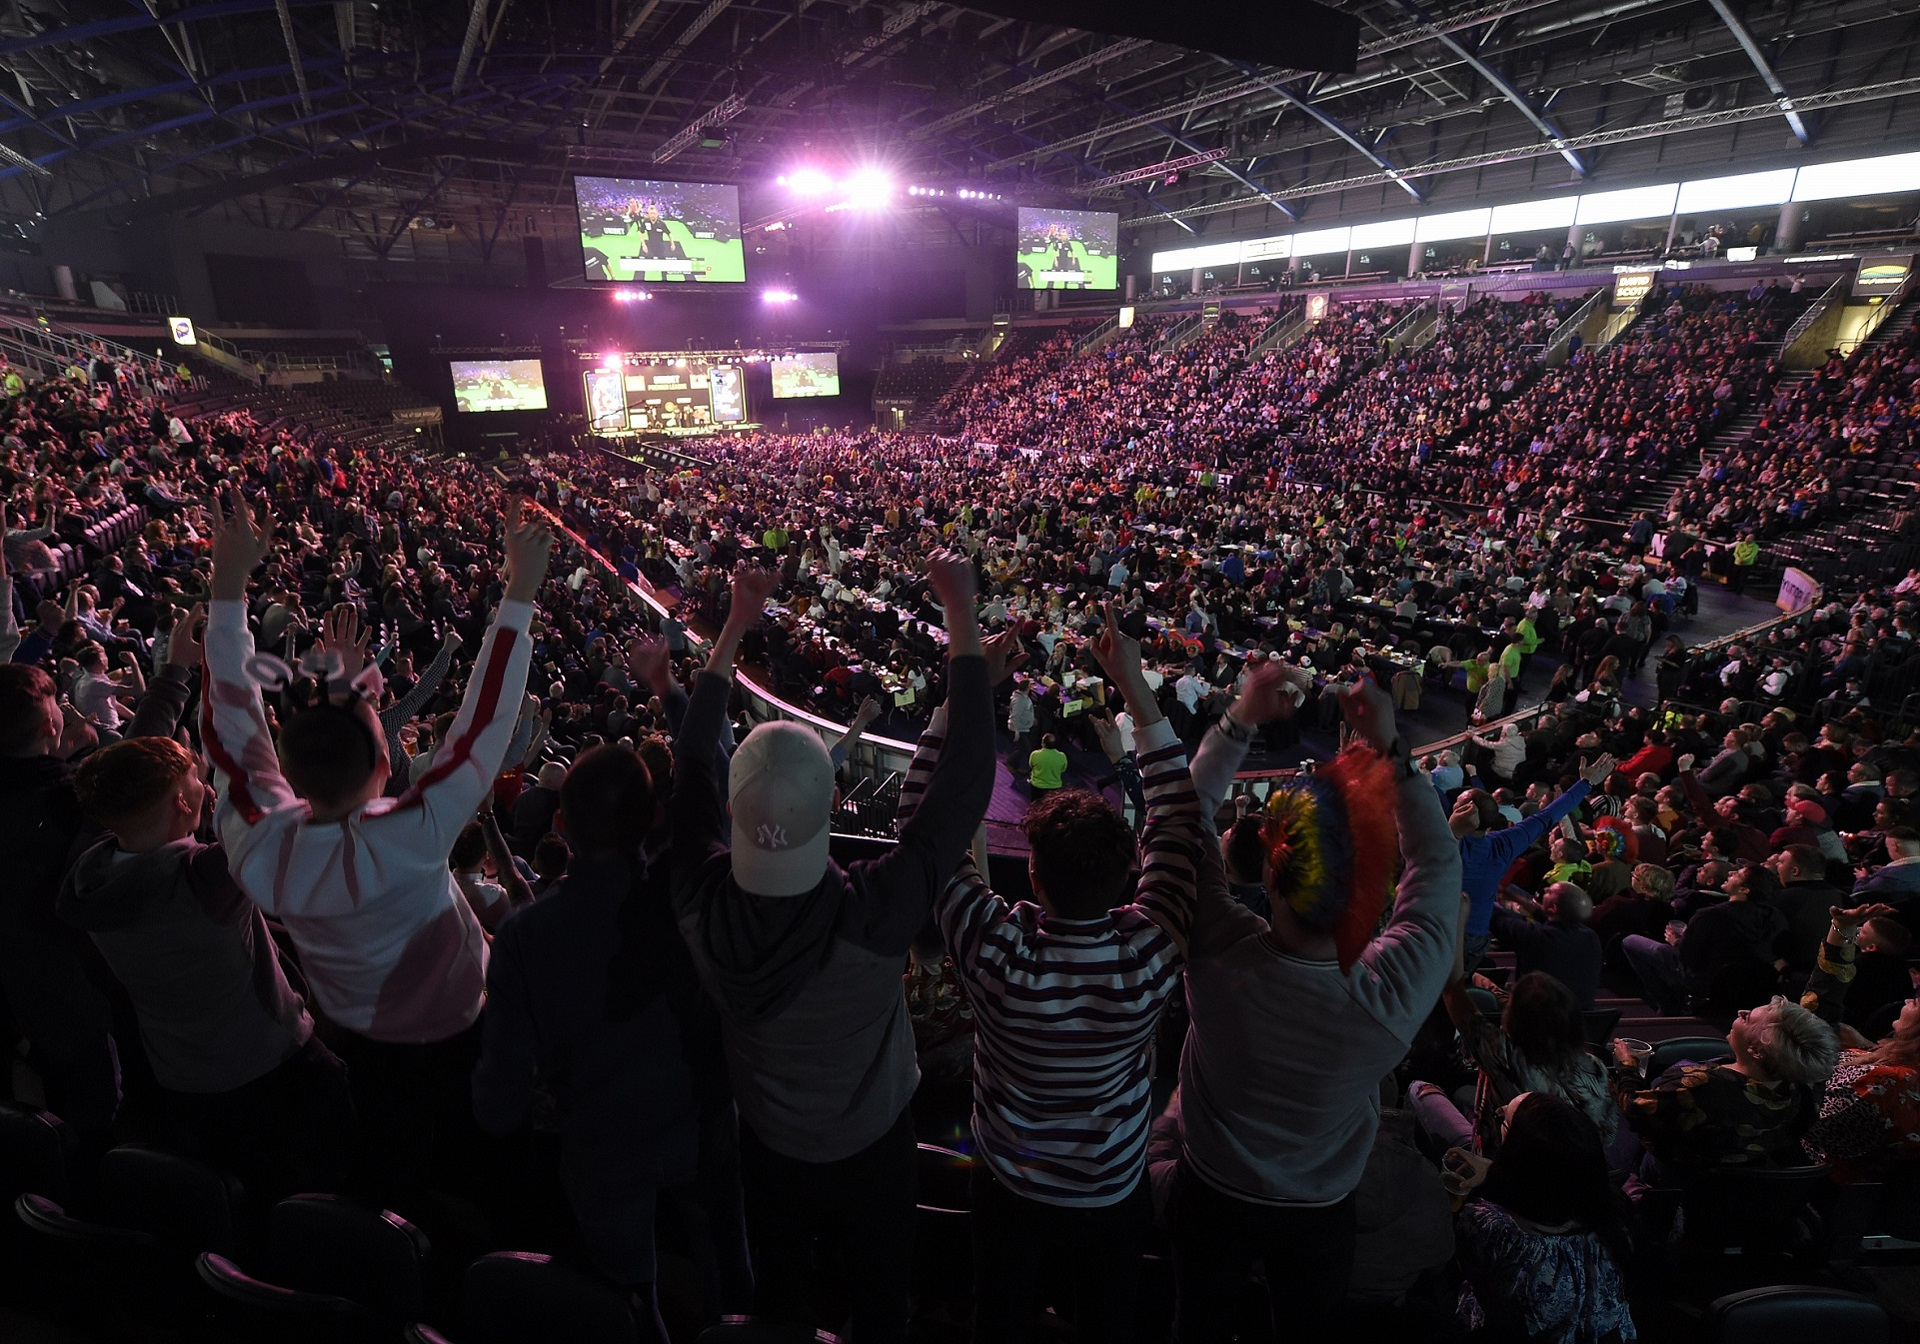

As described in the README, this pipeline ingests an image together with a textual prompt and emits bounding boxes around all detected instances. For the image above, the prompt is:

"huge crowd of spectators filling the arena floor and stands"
[0,266,1920,1344]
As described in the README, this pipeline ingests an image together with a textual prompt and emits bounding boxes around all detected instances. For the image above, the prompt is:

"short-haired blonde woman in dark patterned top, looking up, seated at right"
[1613,995,1839,1185]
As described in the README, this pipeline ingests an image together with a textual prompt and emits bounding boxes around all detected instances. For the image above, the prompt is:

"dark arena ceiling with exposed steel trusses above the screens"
[11,0,1920,257]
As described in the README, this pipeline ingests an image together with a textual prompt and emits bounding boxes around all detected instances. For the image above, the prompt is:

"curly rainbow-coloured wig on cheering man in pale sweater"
[1261,747,1400,972]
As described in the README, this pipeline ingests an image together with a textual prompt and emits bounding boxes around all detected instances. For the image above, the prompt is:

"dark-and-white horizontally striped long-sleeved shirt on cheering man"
[900,718,1210,1208]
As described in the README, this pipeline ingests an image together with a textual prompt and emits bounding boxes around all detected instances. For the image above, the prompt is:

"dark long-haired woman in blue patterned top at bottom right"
[1453,1092,1638,1344]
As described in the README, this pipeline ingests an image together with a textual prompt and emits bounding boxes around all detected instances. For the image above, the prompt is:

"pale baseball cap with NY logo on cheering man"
[728,722,833,897]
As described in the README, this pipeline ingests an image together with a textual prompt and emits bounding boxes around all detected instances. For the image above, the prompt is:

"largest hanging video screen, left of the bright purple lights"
[574,177,747,284]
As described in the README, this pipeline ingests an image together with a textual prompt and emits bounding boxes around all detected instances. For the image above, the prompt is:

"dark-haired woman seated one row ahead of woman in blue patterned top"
[1409,972,1620,1156]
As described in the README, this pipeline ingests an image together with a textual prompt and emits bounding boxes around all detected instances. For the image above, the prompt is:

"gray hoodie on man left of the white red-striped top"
[56,839,313,1092]
